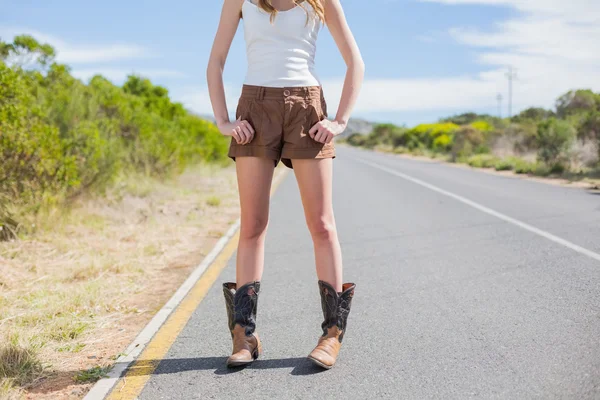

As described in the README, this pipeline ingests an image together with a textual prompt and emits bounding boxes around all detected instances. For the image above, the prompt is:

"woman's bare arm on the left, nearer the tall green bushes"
[206,0,254,144]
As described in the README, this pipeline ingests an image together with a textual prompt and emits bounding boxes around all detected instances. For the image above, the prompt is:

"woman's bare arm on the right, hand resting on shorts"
[309,0,365,143]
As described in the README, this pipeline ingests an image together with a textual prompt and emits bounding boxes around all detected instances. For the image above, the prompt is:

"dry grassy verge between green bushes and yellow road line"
[0,166,244,399]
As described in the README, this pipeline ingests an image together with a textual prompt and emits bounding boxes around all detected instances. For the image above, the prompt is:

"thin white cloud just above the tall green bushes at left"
[0,27,155,65]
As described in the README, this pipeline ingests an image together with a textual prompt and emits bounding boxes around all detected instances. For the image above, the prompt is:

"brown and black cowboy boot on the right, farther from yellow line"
[308,281,356,369]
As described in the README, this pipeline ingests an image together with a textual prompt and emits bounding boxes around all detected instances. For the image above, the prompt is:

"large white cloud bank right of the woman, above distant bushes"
[290,0,600,120]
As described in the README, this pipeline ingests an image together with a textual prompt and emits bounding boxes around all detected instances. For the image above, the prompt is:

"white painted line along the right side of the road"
[355,158,600,261]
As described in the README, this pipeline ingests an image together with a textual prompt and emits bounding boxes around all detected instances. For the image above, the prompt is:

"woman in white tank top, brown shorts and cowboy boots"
[207,0,364,369]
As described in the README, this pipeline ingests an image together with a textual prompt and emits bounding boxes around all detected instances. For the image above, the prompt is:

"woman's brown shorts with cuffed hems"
[229,85,335,168]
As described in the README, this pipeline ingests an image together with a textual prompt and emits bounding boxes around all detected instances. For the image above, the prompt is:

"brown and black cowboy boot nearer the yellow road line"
[223,281,262,367]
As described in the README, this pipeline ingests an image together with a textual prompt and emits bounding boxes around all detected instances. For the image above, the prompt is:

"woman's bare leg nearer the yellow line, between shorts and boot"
[236,157,274,287]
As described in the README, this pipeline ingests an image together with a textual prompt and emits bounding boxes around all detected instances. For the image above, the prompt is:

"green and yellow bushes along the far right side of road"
[346,90,600,184]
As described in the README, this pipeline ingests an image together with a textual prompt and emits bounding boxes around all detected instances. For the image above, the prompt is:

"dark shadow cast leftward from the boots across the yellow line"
[120,357,325,376]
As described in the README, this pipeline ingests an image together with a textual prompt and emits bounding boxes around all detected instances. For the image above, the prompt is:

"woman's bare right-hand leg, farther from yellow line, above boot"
[292,158,342,292]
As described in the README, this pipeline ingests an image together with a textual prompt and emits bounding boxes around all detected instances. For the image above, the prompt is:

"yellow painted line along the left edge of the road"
[106,170,287,400]
